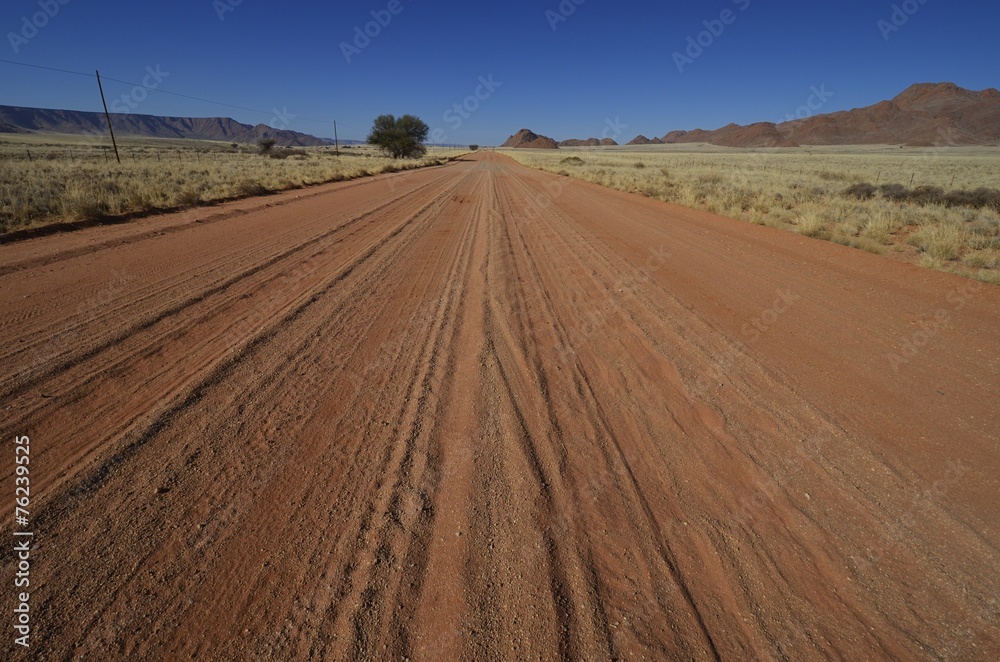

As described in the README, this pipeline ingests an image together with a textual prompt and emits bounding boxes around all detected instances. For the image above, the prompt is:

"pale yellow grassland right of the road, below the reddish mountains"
[504,145,1000,284]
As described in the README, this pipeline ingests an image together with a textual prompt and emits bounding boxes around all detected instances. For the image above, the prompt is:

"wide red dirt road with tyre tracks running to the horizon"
[0,153,1000,660]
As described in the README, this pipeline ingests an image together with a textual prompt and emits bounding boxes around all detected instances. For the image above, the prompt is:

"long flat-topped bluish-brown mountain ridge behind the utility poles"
[0,106,344,147]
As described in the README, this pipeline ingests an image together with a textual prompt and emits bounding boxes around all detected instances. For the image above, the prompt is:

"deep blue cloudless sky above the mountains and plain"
[0,0,1000,145]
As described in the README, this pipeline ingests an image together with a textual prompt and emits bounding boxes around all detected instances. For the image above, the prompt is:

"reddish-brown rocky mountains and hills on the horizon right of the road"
[505,83,1000,147]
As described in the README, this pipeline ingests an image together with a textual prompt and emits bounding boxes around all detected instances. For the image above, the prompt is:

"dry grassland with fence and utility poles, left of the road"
[0,134,459,232]
